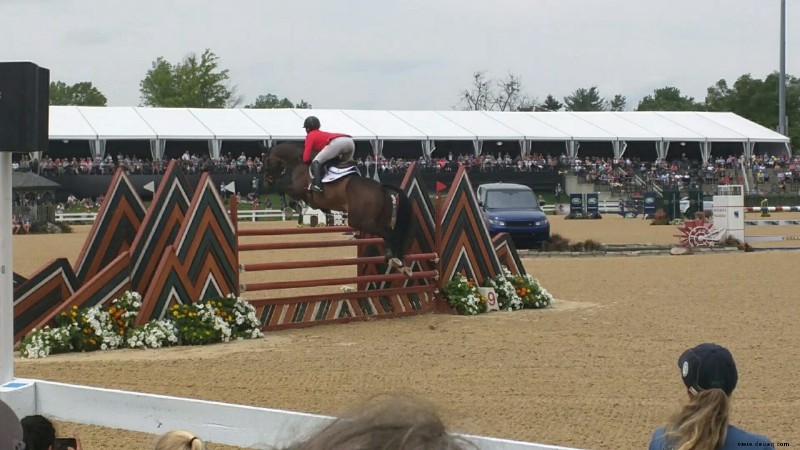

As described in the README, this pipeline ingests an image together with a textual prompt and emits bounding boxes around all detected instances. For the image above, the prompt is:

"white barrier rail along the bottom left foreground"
[0,378,579,450]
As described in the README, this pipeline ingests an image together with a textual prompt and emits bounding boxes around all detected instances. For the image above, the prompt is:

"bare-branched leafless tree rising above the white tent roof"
[456,71,536,111]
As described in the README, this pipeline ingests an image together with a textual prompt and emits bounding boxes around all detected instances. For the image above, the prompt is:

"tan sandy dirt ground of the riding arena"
[7,214,800,450]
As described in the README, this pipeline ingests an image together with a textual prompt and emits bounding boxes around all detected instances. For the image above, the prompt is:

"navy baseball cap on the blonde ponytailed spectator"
[678,343,739,396]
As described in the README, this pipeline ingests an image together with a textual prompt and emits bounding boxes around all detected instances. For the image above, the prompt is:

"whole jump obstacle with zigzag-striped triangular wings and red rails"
[14,161,525,342]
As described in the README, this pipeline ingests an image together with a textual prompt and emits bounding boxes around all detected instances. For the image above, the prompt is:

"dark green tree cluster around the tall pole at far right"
[705,72,800,146]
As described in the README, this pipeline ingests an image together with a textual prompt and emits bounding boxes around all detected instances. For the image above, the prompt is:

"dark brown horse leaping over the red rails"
[260,143,412,276]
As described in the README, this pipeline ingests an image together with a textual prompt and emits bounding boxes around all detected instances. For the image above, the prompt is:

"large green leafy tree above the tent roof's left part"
[139,49,234,108]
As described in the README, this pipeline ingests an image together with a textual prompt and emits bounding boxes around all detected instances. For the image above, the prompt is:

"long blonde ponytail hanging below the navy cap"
[664,389,730,450]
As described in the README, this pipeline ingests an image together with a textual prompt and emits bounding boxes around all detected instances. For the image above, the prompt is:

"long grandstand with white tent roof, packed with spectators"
[10,106,800,202]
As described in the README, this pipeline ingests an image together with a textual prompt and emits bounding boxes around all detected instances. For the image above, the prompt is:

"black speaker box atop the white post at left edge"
[0,62,50,152]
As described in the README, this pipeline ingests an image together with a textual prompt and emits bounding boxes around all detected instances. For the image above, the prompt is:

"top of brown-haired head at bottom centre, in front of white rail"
[287,396,477,450]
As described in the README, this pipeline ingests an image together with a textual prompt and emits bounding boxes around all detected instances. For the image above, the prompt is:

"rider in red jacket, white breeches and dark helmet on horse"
[303,116,356,192]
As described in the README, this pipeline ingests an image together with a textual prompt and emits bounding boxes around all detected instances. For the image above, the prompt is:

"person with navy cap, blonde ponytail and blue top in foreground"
[650,343,770,450]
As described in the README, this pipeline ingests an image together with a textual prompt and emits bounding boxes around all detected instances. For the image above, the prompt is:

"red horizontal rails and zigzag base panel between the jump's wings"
[238,222,439,330]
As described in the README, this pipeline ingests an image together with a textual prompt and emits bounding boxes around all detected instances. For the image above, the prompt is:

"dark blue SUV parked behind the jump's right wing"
[477,183,550,248]
